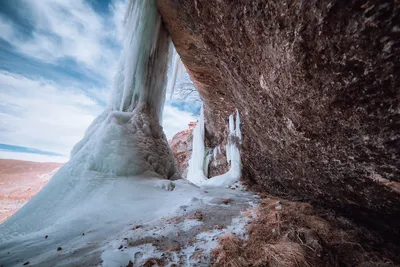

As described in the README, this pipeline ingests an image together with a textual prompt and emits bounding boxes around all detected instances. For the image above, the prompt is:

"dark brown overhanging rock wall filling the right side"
[157,0,400,248]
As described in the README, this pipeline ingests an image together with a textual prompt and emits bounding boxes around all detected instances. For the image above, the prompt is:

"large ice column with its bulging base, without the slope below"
[71,0,179,178]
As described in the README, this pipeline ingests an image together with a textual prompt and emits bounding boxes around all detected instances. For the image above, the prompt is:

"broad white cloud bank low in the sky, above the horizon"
[0,72,102,155]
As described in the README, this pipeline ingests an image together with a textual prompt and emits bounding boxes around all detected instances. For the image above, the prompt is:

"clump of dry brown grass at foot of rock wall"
[212,199,396,267]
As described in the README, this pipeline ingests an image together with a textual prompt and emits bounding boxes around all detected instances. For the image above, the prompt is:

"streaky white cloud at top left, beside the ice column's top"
[0,0,125,81]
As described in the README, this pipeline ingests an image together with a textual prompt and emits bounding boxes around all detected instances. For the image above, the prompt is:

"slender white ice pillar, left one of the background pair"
[187,106,207,184]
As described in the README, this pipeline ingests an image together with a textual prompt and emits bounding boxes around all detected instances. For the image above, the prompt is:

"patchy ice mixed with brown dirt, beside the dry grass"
[102,184,257,266]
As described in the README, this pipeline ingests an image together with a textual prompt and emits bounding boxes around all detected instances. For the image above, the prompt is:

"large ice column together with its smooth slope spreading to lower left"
[0,0,180,266]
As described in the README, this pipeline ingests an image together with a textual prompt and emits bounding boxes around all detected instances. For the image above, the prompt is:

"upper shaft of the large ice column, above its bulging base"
[111,0,171,121]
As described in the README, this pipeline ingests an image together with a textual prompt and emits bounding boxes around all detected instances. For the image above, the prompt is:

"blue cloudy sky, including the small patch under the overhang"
[0,0,200,162]
